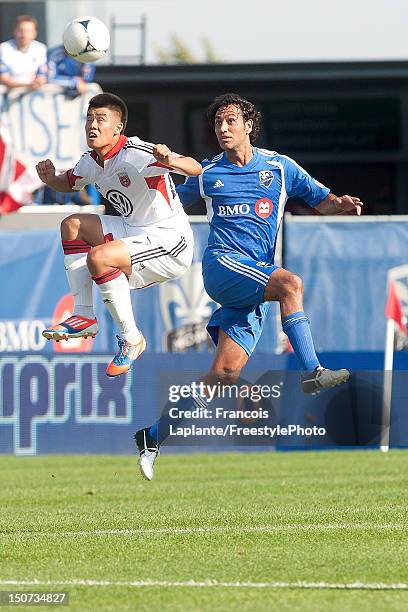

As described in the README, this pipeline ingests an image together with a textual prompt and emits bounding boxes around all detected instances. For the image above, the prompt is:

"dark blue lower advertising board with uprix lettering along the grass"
[0,353,408,455]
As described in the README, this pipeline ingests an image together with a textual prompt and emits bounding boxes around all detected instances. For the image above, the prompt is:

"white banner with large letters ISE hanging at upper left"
[0,83,102,171]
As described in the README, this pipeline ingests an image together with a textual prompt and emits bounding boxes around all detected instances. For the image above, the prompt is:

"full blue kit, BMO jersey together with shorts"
[177,148,330,355]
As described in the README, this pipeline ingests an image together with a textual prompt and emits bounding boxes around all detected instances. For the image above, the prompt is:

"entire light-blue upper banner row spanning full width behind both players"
[0,217,408,353]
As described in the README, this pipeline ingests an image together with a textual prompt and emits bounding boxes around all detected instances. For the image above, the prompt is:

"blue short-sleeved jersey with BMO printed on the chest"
[177,148,330,261]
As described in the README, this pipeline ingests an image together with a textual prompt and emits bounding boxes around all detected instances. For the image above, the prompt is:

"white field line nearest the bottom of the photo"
[0,578,408,591]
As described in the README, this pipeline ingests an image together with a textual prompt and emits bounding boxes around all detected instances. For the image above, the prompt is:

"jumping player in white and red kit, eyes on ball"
[36,93,202,376]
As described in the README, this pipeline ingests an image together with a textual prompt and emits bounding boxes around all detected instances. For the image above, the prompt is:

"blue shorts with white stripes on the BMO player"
[203,250,278,355]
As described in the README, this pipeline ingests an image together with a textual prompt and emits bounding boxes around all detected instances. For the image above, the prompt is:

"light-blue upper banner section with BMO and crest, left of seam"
[0,223,280,354]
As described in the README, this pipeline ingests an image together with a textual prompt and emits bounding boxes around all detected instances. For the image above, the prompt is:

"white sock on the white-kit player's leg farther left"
[64,253,95,319]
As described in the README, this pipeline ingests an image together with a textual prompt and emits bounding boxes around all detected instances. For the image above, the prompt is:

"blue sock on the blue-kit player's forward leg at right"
[282,311,320,372]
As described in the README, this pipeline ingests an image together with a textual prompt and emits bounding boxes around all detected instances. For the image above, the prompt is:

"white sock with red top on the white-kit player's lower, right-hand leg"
[93,268,142,344]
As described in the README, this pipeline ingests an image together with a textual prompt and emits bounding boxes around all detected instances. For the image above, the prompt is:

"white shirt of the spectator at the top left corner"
[0,38,47,85]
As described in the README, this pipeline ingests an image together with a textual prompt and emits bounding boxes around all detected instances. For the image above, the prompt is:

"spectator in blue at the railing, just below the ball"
[48,45,95,98]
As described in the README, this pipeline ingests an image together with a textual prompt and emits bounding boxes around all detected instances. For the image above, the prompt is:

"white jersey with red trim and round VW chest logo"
[67,135,188,228]
